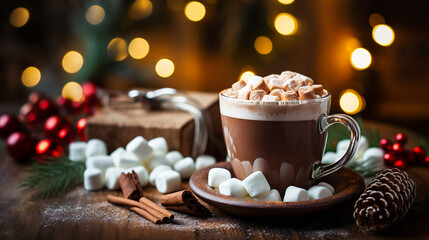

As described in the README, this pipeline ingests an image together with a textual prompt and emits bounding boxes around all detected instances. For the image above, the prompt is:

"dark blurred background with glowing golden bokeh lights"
[0,0,429,136]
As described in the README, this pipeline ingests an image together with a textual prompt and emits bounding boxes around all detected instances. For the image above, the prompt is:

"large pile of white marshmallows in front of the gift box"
[69,136,216,193]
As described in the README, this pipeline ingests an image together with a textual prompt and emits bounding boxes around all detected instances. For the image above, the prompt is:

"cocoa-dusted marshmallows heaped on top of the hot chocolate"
[222,71,328,101]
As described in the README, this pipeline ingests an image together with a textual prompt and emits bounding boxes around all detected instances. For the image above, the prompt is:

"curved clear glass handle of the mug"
[311,114,360,180]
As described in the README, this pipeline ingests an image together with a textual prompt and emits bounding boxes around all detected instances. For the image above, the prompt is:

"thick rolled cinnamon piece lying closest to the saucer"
[161,190,211,217]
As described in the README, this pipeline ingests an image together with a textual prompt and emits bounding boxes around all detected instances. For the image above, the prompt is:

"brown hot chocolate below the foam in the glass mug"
[221,115,326,193]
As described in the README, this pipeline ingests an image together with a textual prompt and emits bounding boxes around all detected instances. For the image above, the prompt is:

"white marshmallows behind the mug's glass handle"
[322,136,386,177]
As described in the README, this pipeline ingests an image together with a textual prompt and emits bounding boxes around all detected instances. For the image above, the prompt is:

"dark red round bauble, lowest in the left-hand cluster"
[6,132,34,161]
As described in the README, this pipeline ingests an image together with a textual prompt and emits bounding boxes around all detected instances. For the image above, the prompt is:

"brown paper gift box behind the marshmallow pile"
[86,92,226,160]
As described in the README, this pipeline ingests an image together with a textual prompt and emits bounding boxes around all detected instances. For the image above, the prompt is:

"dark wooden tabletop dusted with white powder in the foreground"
[0,123,429,240]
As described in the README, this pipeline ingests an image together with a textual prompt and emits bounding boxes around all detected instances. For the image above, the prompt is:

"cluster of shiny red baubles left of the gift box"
[0,83,101,162]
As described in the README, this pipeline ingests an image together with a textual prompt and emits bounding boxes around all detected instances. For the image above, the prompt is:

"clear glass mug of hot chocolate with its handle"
[219,91,360,195]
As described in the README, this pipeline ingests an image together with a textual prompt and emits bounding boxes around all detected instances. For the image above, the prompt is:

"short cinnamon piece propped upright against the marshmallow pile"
[119,171,143,201]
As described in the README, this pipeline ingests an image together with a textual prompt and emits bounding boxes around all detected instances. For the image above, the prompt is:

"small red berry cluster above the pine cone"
[380,133,429,169]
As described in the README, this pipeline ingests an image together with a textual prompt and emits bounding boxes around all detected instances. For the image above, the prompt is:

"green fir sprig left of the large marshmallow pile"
[19,157,85,199]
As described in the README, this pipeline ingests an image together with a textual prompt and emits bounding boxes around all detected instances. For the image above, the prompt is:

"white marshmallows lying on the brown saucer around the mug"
[208,168,335,202]
